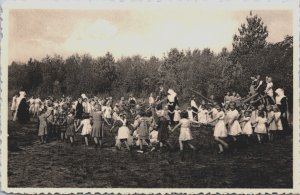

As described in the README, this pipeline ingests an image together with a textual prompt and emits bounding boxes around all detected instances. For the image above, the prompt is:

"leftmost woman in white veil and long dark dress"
[17,91,30,124]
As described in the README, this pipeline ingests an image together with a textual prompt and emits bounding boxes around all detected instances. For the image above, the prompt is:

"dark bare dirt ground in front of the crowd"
[8,115,293,188]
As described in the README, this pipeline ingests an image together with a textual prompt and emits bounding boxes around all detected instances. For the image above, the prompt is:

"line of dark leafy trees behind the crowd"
[8,13,293,105]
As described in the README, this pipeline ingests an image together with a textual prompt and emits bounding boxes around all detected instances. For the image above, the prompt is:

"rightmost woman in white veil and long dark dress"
[275,88,290,136]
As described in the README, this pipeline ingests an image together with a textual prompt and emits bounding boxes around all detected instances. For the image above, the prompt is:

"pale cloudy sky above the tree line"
[8,8,293,63]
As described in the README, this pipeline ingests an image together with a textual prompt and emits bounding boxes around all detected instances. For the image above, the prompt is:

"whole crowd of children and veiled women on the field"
[11,75,289,159]
